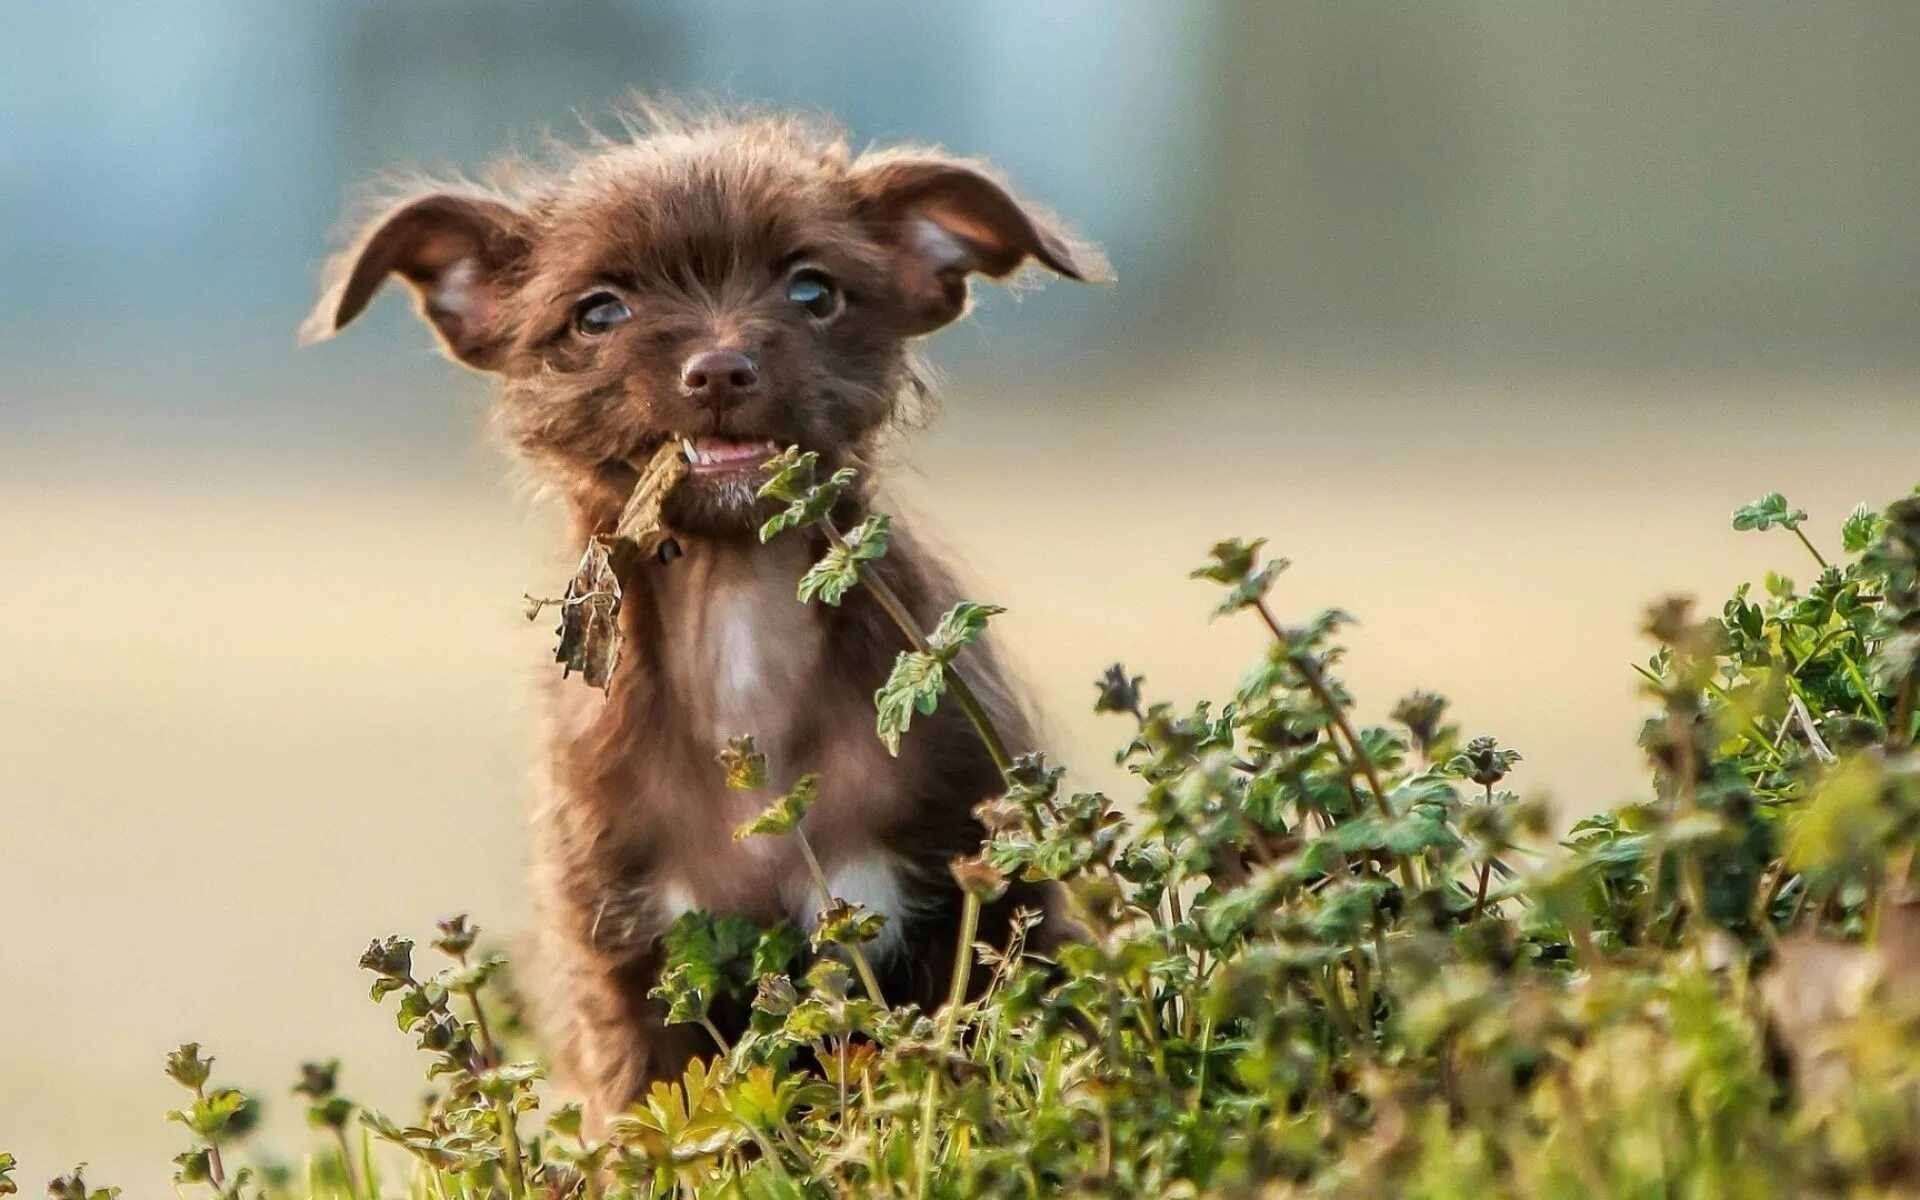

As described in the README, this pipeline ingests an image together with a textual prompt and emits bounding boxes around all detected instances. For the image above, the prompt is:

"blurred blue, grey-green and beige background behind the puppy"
[0,0,1920,1194]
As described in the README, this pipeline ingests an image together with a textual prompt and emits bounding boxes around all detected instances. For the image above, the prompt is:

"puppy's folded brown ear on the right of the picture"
[852,152,1112,334]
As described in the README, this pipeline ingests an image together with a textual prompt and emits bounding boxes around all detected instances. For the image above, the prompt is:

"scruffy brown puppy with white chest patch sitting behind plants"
[305,105,1106,1116]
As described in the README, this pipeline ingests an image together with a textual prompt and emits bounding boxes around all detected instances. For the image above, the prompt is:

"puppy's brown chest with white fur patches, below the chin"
[591,540,929,958]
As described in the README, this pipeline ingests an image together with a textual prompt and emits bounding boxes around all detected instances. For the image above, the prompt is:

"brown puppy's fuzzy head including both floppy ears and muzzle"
[303,108,1106,534]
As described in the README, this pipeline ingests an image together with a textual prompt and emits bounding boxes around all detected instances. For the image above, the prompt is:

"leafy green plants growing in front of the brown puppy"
[22,481,1920,1200]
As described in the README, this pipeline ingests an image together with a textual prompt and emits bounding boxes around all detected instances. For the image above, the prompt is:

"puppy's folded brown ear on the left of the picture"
[300,192,528,371]
